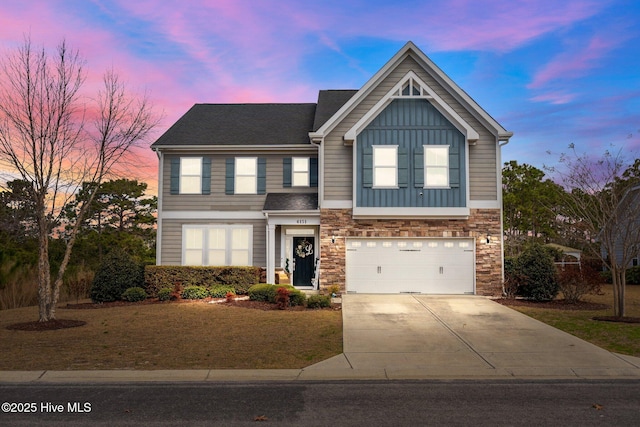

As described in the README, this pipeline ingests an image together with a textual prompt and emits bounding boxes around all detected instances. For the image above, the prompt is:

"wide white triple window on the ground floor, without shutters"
[182,225,253,266]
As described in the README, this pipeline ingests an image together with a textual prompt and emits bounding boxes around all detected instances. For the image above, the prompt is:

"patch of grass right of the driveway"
[511,285,640,357]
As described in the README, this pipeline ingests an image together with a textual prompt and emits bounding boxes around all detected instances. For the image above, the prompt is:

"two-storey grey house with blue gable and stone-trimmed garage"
[152,42,512,295]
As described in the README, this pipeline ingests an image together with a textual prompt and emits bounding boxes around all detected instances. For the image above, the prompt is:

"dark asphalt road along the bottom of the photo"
[0,380,640,426]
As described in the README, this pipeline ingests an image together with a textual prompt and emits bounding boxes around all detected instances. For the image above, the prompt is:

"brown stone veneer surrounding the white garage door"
[320,209,502,296]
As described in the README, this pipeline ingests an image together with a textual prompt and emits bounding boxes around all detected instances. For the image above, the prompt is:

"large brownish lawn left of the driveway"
[0,302,342,370]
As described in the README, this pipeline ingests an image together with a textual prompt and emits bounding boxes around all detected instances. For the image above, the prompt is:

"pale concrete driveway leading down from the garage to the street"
[302,294,640,379]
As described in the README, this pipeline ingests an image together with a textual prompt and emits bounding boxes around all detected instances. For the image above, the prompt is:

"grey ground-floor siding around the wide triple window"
[160,218,267,267]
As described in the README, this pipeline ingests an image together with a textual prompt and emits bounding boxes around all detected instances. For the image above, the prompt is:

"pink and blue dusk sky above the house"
[0,0,640,191]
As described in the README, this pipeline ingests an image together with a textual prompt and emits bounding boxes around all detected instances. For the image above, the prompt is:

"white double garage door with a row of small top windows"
[346,239,474,294]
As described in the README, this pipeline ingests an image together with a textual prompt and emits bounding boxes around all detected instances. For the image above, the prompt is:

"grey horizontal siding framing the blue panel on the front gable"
[323,57,498,200]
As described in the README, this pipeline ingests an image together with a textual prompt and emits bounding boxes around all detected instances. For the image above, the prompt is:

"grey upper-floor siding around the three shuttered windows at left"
[162,151,318,211]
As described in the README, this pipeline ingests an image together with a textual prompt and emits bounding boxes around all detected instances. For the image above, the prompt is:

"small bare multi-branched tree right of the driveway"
[549,145,640,317]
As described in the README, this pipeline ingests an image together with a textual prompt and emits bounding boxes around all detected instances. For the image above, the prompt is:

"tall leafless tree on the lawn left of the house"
[0,37,158,321]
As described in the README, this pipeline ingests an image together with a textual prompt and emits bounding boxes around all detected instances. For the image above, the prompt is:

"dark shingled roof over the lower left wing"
[151,103,316,148]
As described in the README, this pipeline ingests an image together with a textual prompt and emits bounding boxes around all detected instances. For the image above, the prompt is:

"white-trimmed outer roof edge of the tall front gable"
[309,41,513,141]
